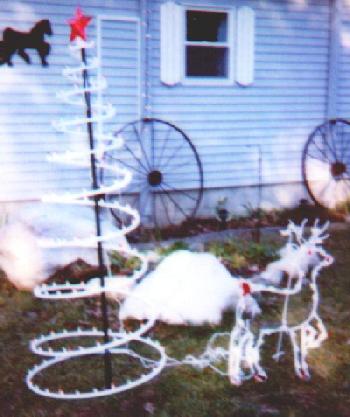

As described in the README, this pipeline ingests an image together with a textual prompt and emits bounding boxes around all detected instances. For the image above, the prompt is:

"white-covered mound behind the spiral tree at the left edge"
[0,203,127,290]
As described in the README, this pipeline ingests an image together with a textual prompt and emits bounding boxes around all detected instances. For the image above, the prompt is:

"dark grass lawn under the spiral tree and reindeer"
[0,230,350,417]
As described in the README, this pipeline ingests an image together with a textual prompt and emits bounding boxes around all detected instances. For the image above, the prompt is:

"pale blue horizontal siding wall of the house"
[0,0,350,219]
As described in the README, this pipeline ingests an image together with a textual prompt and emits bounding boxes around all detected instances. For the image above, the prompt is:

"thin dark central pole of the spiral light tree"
[81,48,112,388]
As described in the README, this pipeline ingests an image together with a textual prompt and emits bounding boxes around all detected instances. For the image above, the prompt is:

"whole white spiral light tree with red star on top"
[26,8,166,399]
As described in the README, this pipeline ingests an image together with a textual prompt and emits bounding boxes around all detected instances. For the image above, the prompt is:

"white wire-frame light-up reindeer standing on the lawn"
[228,222,333,385]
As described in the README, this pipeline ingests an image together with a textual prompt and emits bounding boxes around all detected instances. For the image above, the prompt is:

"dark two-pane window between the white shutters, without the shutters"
[184,10,232,79]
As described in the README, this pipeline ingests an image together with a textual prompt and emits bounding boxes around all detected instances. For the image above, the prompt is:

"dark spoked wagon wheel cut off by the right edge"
[302,119,350,209]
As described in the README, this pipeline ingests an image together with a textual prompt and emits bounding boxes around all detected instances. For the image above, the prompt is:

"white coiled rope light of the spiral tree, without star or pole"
[26,22,167,399]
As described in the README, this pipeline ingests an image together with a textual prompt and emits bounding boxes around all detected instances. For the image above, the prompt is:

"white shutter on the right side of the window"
[236,6,255,87]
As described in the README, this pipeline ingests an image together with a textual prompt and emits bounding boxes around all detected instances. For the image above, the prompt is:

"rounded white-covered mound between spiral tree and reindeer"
[120,250,259,325]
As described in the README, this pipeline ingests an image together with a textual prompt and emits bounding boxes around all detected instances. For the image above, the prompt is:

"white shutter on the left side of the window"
[160,1,183,86]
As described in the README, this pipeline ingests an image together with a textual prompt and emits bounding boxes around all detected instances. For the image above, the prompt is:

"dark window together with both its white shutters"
[160,0,255,87]
